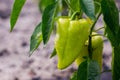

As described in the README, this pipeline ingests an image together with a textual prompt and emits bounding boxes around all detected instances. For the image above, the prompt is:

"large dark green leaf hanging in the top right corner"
[101,0,119,35]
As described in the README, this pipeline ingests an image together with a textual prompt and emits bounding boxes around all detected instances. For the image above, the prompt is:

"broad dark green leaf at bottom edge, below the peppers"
[77,60,100,80]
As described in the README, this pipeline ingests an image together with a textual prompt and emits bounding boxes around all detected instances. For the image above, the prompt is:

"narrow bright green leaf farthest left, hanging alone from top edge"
[10,0,26,31]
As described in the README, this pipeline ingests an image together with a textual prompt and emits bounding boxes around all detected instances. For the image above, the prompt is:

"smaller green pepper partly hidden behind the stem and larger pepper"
[75,32,103,69]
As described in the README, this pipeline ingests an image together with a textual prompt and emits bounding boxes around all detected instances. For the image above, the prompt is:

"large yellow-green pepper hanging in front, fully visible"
[55,17,91,69]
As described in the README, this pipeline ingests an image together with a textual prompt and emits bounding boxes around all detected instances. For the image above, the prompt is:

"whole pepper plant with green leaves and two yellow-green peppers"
[10,0,120,80]
